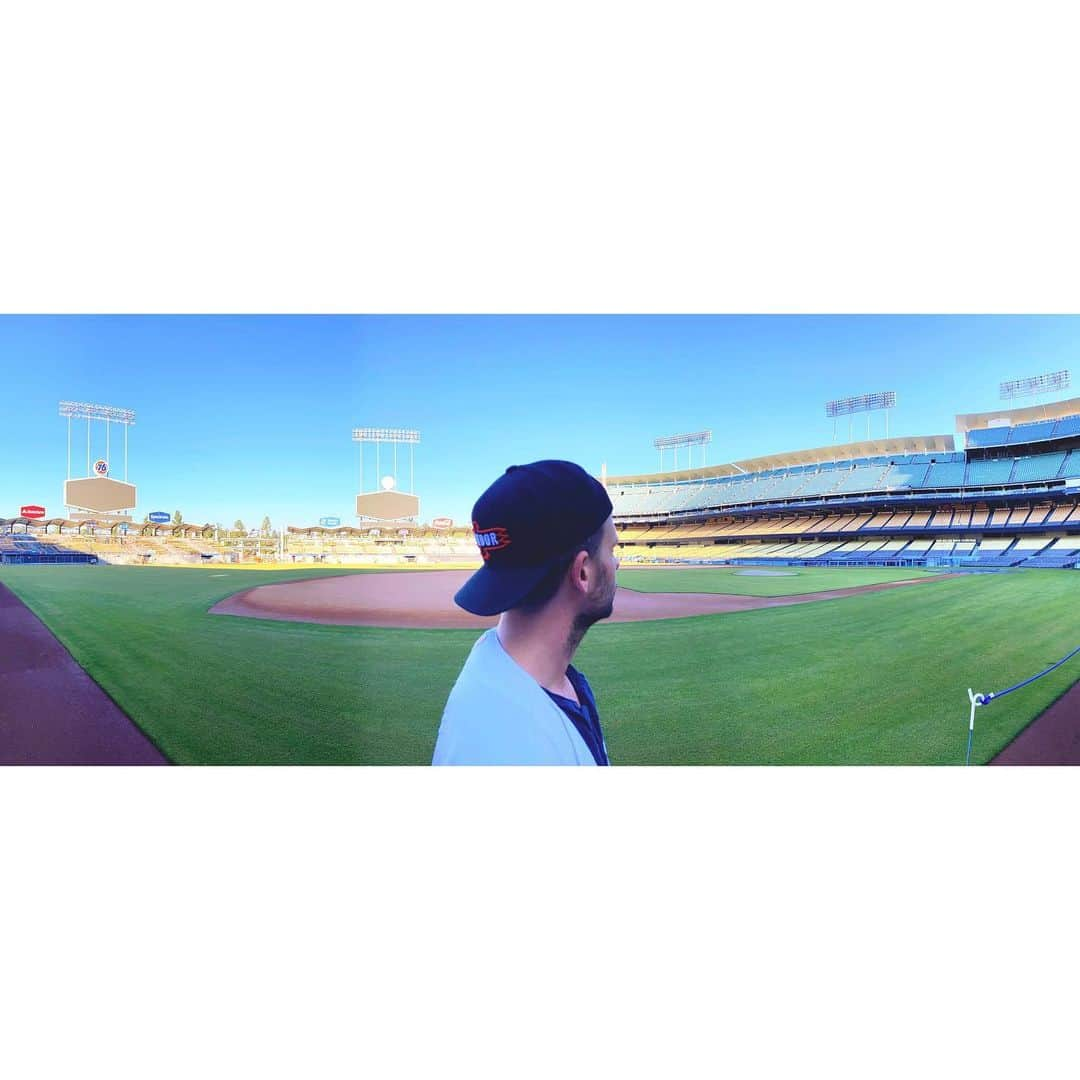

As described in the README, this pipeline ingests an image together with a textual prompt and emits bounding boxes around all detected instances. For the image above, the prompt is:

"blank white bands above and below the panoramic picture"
[0,2,1080,1080]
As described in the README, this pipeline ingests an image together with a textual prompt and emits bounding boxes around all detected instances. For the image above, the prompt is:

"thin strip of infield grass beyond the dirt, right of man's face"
[619,566,940,596]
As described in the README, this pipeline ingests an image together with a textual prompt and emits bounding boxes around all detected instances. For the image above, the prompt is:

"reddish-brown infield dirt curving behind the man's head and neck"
[210,570,948,630]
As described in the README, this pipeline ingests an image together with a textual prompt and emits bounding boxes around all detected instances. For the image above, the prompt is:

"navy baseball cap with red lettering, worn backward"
[454,461,612,615]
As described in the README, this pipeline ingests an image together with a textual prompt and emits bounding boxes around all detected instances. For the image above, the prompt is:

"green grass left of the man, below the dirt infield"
[0,566,455,765]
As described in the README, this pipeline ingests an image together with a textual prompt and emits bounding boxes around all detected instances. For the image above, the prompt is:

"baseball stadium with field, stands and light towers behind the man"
[0,362,1080,765]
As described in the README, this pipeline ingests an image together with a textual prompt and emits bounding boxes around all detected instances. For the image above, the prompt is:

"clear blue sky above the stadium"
[0,315,1080,527]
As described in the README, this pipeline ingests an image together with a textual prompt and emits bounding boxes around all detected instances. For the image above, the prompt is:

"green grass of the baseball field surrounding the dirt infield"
[0,566,1080,765]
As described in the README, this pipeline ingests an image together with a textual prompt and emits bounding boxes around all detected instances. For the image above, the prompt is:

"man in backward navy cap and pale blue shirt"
[432,461,619,765]
